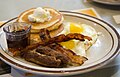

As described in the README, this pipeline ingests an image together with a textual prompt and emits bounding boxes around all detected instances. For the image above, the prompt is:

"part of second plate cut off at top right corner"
[92,0,120,5]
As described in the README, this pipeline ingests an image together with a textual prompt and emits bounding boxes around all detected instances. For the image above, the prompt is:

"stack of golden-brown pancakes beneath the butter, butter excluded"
[17,7,64,41]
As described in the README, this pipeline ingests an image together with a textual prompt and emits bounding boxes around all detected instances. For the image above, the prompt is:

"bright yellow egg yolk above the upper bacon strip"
[70,23,83,33]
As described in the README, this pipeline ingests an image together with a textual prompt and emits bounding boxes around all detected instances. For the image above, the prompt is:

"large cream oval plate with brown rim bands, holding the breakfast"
[0,11,120,76]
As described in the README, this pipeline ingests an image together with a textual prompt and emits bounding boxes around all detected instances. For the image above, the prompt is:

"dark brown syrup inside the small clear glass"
[7,30,30,50]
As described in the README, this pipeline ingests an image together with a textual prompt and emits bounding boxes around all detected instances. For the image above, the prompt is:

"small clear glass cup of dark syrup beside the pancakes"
[3,22,31,50]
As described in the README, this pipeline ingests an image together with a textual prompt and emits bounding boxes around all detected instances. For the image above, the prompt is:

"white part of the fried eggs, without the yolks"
[59,22,98,57]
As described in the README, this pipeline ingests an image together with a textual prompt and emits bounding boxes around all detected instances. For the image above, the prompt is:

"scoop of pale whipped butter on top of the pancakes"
[28,7,52,23]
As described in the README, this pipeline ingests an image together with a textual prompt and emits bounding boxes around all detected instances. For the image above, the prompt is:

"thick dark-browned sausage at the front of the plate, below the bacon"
[22,50,61,67]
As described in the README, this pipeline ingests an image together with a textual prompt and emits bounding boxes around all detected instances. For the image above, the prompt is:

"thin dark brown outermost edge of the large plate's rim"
[0,11,120,75]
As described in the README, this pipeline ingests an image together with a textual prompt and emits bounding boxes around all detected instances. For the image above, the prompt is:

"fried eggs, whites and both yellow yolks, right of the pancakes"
[60,22,98,57]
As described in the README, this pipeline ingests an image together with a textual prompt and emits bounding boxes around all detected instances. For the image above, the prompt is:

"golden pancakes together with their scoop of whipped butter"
[17,7,64,33]
